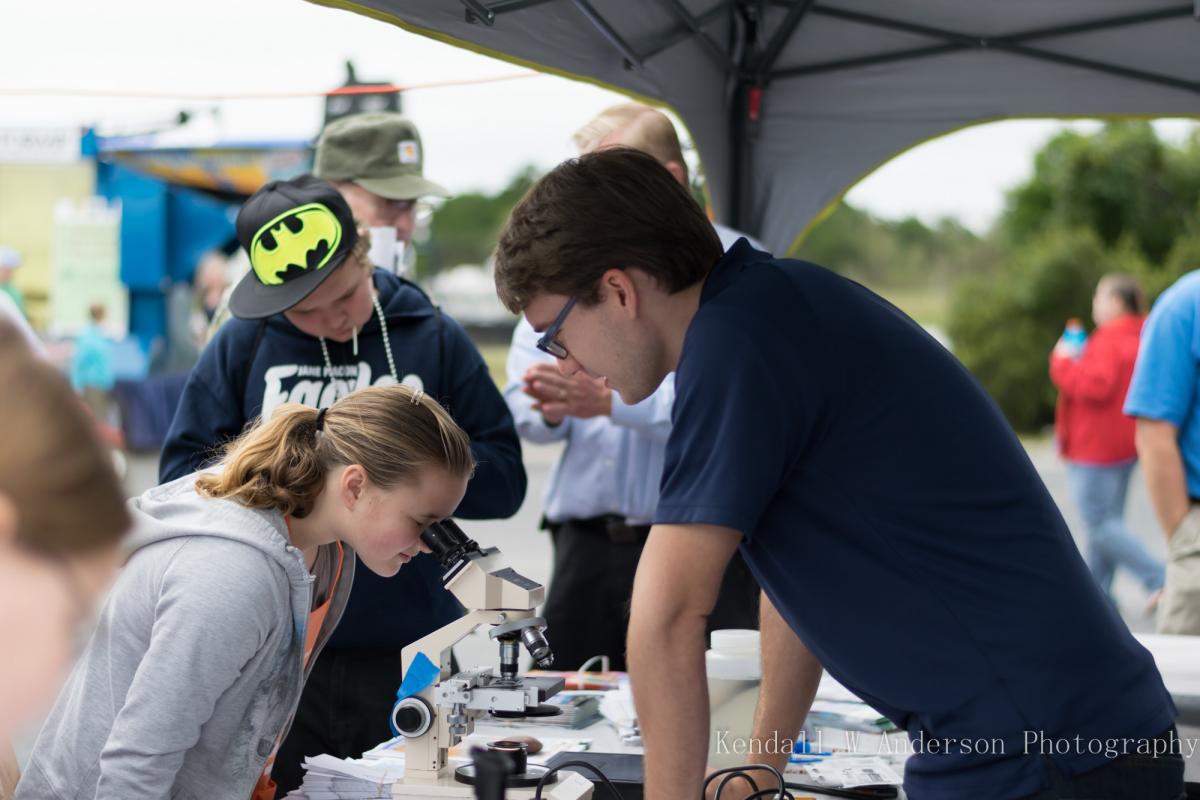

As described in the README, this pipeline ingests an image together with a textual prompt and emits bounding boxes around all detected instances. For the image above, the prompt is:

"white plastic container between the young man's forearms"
[704,630,762,768]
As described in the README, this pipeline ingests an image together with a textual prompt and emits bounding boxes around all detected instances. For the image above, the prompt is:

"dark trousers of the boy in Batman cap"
[271,648,403,798]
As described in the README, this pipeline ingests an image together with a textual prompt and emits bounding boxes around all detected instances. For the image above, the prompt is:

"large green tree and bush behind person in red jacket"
[948,121,1200,431]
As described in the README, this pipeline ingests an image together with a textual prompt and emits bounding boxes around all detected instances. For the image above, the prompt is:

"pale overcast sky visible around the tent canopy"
[0,0,1195,230]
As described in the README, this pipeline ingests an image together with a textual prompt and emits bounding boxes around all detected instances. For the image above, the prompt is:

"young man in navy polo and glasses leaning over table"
[496,150,1183,800]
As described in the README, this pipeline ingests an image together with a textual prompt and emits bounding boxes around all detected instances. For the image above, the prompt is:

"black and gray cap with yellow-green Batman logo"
[229,175,358,319]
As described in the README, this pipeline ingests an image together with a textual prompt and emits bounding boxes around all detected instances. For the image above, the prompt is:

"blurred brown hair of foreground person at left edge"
[0,323,130,555]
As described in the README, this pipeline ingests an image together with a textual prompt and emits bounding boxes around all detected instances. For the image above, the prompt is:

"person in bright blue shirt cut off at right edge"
[1124,271,1200,636]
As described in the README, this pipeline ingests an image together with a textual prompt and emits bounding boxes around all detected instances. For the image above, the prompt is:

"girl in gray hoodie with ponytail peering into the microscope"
[17,385,475,800]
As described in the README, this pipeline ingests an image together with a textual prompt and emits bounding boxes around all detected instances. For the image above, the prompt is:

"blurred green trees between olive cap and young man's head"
[416,167,538,277]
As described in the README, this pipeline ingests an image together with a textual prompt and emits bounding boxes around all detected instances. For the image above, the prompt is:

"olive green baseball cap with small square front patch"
[312,112,450,200]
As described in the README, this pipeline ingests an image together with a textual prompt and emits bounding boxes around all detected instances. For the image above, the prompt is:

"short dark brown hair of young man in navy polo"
[496,148,722,312]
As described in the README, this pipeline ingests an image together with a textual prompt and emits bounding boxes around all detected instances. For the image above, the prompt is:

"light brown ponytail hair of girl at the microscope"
[196,385,475,517]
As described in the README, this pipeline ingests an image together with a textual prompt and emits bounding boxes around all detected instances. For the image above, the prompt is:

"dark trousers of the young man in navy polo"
[1024,727,1188,800]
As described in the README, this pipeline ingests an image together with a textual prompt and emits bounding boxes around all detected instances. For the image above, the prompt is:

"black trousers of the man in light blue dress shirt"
[545,518,760,670]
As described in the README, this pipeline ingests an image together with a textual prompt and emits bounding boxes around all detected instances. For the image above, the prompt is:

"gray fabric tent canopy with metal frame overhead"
[313,0,1200,253]
